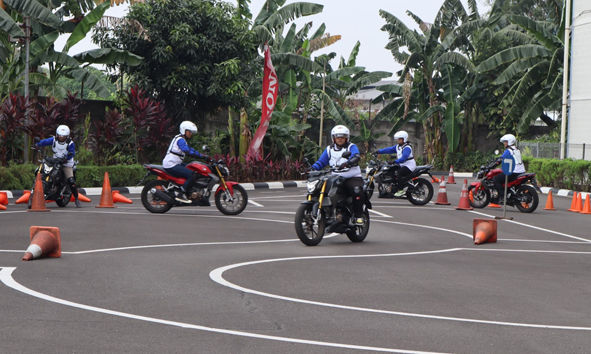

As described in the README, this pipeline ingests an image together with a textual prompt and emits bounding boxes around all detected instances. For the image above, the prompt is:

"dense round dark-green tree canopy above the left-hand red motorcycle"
[93,0,262,121]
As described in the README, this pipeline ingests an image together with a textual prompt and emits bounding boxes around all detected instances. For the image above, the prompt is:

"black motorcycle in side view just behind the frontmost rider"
[366,156,433,205]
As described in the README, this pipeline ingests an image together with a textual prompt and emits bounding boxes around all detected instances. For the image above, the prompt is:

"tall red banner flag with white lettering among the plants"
[248,44,279,159]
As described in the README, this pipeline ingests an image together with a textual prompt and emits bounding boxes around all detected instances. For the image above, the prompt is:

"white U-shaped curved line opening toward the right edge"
[209,248,591,331]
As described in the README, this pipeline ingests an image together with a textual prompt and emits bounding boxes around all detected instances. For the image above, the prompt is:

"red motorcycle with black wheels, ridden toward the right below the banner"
[138,149,248,215]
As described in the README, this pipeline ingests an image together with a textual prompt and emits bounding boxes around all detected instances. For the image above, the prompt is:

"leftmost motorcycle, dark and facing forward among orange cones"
[28,146,76,209]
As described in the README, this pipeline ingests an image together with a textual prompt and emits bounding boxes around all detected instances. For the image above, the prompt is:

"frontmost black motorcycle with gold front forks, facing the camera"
[295,151,371,246]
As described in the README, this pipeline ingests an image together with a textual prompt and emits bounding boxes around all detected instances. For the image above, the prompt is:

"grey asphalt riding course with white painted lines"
[0,179,591,354]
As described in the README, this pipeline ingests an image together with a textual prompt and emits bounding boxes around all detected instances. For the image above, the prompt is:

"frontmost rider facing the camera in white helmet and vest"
[312,125,365,226]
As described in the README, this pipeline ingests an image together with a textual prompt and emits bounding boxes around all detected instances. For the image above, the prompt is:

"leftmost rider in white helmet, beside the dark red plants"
[36,125,82,208]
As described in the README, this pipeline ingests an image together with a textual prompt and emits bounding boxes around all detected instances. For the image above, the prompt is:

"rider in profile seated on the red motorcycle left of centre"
[162,121,211,203]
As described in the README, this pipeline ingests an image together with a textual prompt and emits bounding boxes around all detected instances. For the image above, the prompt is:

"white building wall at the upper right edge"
[566,0,591,160]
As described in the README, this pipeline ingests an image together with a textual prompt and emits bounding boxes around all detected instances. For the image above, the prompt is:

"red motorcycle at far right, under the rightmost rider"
[468,160,541,213]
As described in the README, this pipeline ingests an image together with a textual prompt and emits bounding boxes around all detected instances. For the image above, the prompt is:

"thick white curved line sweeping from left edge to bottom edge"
[0,267,442,354]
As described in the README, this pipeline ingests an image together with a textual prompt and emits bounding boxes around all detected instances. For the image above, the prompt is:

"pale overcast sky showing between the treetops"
[56,0,487,75]
